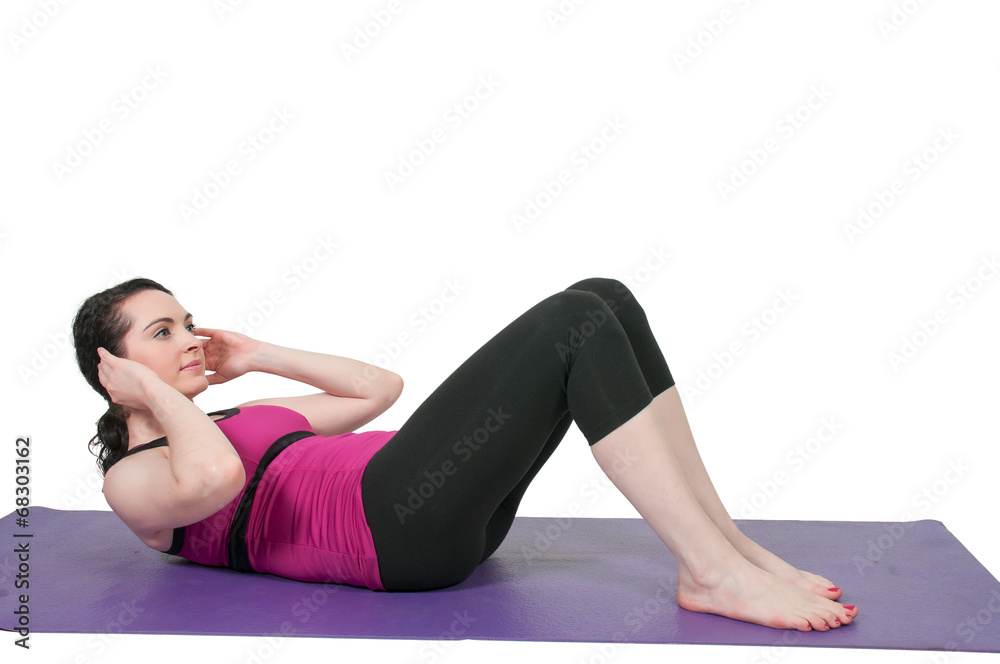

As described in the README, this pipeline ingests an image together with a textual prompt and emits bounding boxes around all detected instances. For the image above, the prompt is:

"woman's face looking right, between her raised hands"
[122,290,208,399]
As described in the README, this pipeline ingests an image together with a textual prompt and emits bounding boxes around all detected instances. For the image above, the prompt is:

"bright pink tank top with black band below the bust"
[128,405,396,590]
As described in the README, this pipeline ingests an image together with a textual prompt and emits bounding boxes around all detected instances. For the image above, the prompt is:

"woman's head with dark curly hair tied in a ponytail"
[73,278,208,472]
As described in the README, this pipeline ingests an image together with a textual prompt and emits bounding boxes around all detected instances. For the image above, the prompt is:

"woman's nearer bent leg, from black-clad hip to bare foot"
[362,278,852,629]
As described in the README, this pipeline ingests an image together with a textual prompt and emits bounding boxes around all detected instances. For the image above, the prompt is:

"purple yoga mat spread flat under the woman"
[0,507,1000,652]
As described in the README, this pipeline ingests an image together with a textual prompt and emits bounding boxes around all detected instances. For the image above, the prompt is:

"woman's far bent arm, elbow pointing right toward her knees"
[194,328,403,436]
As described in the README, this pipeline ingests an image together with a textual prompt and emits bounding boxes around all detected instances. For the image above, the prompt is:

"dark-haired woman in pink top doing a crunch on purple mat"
[73,278,858,631]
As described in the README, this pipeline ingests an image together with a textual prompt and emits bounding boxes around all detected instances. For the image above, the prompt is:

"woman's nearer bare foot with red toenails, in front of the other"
[677,556,858,632]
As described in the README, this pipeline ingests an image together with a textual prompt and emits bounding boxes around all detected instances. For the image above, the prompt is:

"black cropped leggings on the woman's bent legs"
[361,278,674,590]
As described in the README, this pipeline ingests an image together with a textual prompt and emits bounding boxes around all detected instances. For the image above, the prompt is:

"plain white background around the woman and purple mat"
[0,0,1000,663]
